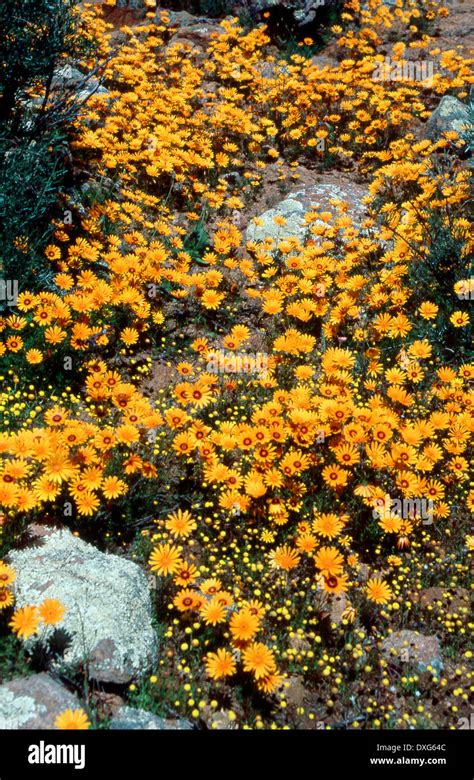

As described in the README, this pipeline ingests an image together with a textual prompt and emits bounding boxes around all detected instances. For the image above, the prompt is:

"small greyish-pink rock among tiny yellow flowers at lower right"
[381,629,443,672]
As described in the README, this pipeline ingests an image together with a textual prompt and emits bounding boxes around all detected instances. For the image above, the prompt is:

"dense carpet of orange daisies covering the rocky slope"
[0,0,474,730]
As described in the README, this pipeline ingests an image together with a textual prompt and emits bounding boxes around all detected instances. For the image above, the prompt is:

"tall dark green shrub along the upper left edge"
[0,0,100,291]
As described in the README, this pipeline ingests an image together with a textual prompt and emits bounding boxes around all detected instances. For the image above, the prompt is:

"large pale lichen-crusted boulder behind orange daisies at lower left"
[10,530,157,683]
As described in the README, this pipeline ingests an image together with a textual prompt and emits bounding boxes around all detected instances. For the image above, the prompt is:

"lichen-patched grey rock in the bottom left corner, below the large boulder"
[0,672,80,730]
